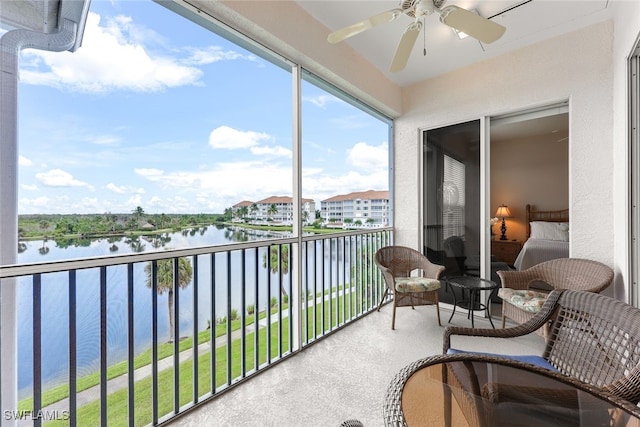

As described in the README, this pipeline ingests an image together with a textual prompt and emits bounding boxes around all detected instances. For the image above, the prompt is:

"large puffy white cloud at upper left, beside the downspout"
[20,12,202,92]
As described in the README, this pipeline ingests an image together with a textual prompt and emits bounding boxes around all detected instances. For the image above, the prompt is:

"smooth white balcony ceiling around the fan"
[297,0,613,86]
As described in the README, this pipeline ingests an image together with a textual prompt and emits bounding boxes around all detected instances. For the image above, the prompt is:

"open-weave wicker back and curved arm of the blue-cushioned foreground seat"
[443,290,640,404]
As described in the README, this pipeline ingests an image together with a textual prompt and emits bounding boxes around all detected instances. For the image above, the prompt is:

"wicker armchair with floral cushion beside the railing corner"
[375,246,444,329]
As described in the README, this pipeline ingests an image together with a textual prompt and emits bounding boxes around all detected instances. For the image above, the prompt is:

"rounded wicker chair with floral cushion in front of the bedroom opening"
[498,258,613,337]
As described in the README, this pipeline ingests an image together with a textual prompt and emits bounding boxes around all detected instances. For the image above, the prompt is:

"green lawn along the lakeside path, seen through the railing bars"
[33,286,376,426]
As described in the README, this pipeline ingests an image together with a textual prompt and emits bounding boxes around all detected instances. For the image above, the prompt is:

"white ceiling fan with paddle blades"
[327,0,506,73]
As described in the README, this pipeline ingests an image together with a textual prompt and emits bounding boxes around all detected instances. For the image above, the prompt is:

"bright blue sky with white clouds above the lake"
[13,0,388,214]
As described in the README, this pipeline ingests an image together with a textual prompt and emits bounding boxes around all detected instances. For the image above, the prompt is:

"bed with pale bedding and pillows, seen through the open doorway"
[514,205,569,270]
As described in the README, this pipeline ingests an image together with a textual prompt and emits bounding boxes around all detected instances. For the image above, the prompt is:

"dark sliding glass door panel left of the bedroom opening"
[422,120,484,303]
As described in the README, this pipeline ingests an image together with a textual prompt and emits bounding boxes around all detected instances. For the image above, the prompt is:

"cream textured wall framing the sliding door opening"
[395,21,614,265]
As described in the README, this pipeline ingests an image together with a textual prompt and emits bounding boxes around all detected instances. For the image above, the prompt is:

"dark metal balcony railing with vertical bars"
[0,229,391,426]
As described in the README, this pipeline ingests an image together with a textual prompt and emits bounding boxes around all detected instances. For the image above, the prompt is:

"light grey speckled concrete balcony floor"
[171,304,544,427]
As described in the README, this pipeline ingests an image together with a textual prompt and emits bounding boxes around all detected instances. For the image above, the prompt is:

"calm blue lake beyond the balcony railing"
[18,226,337,398]
